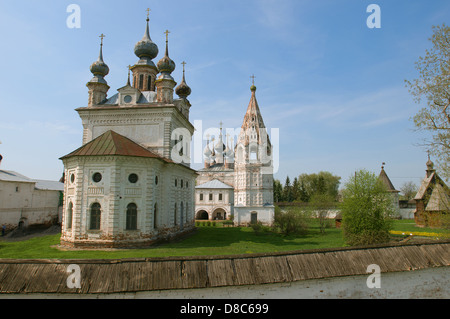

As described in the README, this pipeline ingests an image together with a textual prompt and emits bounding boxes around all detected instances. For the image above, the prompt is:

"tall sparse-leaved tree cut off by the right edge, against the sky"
[405,24,450,179]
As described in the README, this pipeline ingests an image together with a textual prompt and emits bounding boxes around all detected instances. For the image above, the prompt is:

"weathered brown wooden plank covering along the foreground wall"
[0,241,450,294]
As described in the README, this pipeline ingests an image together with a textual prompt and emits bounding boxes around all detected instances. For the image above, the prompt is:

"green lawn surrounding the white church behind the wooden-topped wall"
[0,220,448,259]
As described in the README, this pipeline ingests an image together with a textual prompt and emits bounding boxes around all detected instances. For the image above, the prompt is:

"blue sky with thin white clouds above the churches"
[0,0,450,189]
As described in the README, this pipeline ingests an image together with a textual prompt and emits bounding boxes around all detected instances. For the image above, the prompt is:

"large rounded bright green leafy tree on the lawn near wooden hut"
[341,170,394,245]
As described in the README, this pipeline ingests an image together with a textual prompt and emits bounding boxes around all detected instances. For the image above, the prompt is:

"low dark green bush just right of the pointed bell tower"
[274,207,308,236]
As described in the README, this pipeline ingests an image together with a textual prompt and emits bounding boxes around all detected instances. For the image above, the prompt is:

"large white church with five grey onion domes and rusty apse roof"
[61,13,197,247]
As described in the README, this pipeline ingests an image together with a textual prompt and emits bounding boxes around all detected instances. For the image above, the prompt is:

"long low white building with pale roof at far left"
[0,170,64,229]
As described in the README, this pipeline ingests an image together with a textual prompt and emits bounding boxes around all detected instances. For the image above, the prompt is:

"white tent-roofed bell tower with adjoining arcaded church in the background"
[195,85,274,225]
